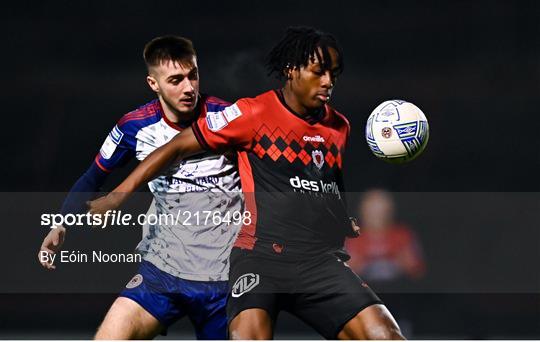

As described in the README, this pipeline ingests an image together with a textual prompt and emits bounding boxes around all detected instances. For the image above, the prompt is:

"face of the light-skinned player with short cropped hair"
[148,56,199,114]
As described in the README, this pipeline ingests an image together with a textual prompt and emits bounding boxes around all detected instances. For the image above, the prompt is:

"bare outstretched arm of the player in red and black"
[88,127,204,214]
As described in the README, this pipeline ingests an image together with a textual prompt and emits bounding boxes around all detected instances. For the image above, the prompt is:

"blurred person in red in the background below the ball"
[345,189,426,338]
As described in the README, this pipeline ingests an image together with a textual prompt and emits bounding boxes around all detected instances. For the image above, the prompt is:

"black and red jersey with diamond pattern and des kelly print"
[193,91,351,256]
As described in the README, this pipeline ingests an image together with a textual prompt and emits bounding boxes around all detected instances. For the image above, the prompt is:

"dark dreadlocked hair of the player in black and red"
[266,26,344,79]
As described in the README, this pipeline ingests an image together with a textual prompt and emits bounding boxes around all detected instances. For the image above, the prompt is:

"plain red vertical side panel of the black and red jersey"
[234,152,257,250]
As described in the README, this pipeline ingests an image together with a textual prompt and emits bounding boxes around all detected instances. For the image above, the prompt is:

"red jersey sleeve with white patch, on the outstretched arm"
[192,99,259,150]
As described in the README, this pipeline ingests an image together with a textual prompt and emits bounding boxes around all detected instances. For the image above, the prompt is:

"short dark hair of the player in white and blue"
[143,35,197,68]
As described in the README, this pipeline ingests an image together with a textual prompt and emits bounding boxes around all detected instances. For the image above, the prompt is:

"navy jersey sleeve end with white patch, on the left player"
[95,123,136,172]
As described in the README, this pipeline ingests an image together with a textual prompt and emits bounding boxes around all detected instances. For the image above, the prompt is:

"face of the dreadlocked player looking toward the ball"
[291,48,339,111]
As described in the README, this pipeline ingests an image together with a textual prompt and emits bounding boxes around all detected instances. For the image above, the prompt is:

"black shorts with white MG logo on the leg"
[227,248,382,339]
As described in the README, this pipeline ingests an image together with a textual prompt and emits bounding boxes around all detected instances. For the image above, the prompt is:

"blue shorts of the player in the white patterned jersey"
[120,261,227,340]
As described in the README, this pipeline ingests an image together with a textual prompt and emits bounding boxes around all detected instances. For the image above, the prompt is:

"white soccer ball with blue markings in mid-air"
[366,100,429,163]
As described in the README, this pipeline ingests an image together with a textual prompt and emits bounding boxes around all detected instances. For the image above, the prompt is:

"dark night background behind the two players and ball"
[0,1,540,339]
